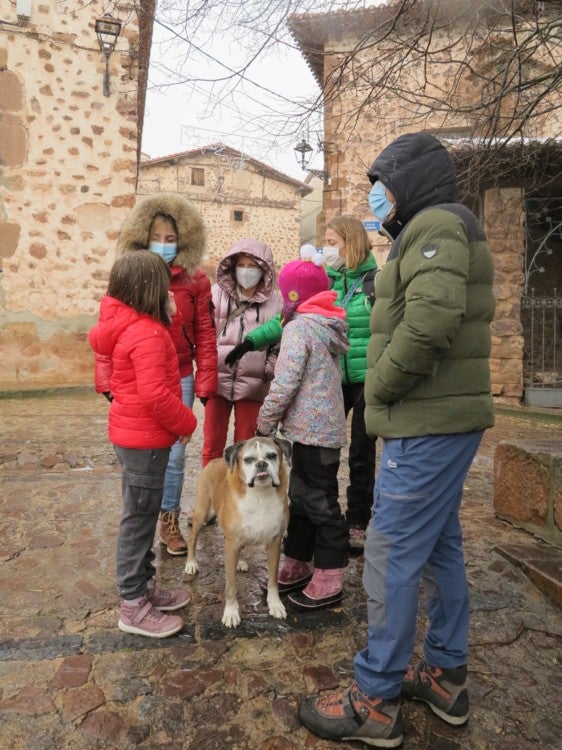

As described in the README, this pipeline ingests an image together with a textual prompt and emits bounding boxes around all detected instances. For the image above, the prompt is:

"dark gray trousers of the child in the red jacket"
[113,445,170,599]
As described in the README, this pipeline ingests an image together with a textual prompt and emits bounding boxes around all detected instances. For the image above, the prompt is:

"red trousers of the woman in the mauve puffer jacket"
[201,396,262,466]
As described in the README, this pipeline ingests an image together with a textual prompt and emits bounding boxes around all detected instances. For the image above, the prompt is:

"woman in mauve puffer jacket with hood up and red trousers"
[203,238,283,466]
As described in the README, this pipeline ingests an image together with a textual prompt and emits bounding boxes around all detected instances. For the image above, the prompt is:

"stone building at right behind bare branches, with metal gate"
[289,0,562,406]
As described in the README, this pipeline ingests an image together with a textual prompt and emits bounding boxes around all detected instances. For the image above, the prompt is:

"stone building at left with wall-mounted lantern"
[0,0,154,391]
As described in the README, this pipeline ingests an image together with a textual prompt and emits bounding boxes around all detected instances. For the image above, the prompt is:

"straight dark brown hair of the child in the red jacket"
[107,250,171,325]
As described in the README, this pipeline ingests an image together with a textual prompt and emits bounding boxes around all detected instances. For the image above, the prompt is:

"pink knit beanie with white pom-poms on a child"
[277,245,330,325]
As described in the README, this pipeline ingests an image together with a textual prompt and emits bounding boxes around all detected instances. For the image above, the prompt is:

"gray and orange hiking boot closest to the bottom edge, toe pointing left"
[299,683,403,747]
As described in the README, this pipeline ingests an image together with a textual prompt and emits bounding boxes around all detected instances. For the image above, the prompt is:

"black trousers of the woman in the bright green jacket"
[342,383,376,529]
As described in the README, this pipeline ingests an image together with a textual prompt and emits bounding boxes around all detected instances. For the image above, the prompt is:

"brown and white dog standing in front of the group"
[185,437,291,628]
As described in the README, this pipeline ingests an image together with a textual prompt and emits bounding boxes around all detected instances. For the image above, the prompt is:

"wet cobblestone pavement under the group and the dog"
[0,391,562,750]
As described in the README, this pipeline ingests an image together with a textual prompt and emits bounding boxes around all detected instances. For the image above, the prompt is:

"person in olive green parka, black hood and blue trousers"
[299,133,495,748]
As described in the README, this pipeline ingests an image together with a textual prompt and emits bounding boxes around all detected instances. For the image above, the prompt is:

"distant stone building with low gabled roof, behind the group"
[138,143,312,276]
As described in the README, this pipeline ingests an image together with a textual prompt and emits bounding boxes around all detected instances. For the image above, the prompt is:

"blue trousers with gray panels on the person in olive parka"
[355,431,482,698]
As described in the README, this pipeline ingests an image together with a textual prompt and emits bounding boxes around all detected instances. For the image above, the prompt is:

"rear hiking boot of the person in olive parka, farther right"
[402,661,468,727]
